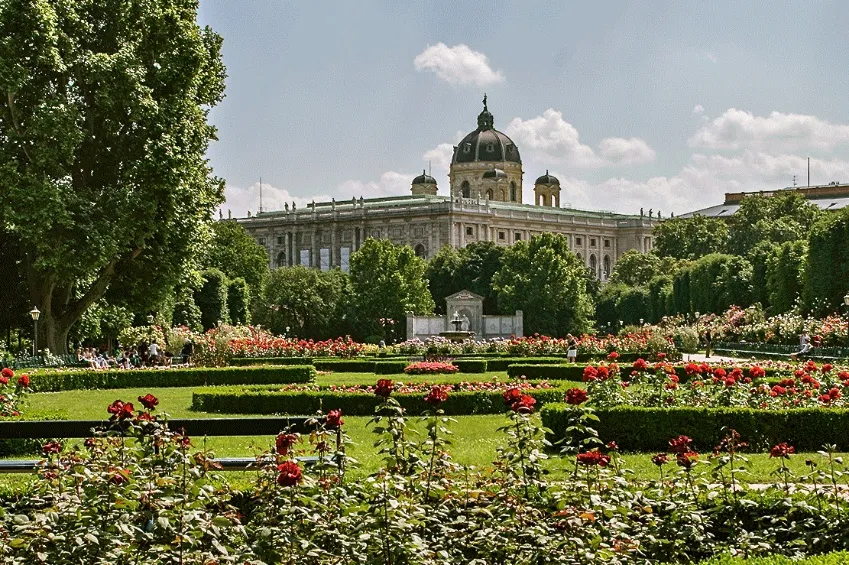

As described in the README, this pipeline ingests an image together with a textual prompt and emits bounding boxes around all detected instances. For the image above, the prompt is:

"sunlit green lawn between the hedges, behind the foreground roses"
[9,386,849,483]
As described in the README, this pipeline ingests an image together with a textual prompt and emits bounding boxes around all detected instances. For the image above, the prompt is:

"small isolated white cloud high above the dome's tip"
[413,43,504,86]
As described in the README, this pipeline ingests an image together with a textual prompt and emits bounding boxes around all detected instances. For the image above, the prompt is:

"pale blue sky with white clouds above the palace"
[198,0,849,217]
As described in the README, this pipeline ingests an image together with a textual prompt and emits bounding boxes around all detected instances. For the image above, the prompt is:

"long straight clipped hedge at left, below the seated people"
[30,365,315,392]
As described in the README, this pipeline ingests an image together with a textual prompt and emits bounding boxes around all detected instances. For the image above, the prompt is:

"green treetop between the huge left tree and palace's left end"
[201,220,268,294]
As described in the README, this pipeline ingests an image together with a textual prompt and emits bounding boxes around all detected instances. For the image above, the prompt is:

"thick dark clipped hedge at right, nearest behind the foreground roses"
[541,403,849,452]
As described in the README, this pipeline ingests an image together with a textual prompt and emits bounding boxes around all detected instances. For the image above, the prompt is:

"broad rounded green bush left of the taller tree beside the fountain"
[255,265,350,339]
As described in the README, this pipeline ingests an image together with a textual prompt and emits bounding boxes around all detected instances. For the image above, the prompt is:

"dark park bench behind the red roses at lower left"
[0,416,342,473]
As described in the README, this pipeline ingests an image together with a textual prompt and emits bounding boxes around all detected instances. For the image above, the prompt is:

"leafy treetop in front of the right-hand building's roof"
[728,191,823,255]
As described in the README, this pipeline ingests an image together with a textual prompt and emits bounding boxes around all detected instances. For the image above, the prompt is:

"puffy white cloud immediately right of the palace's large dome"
[506,108,655,167]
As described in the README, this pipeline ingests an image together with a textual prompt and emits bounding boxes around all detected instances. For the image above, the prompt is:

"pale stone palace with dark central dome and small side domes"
[237,96,659,281]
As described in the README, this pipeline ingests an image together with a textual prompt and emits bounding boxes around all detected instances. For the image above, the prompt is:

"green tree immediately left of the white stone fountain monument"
[351,238,434,341]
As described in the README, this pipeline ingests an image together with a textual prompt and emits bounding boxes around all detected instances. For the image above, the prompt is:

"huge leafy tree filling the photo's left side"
[0,0,225,351]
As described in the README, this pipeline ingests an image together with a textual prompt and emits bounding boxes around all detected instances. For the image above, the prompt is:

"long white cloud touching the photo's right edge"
[689,108,849,153]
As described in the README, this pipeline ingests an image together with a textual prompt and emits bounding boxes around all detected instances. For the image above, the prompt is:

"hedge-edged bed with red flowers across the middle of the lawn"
[192,381,564,416]
